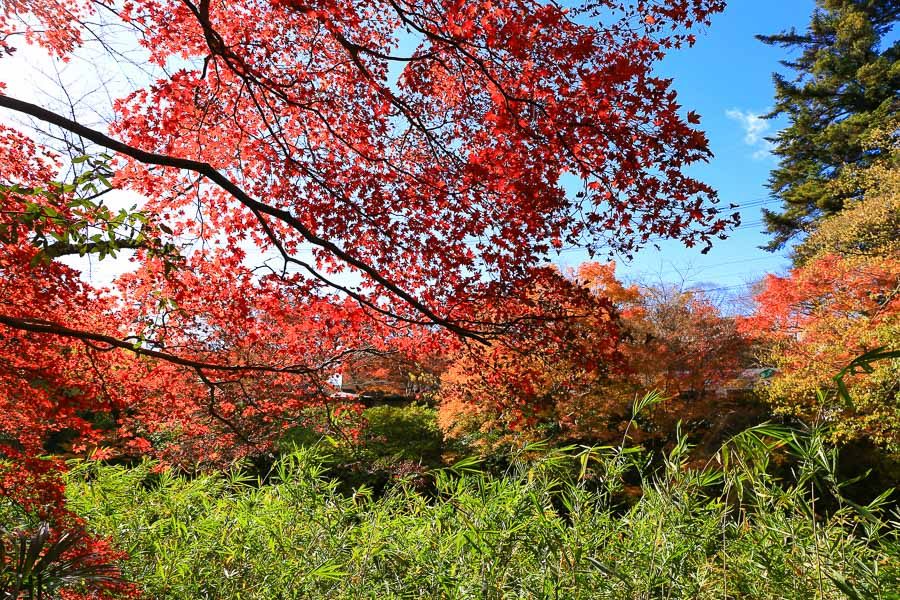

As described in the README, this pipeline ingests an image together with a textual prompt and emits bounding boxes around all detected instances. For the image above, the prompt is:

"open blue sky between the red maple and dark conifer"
[554,0,814,292]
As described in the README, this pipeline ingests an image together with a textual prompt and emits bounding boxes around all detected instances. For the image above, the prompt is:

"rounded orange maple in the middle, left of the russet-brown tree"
[438,269,621,449]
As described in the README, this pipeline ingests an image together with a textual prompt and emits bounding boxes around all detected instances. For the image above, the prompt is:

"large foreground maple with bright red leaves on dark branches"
[0,0,736,592]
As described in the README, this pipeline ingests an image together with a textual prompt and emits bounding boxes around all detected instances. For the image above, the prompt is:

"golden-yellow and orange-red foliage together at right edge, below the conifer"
[743,125,900,455]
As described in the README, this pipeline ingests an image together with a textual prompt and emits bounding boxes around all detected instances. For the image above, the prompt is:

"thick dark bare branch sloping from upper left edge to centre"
[0,94,487,343]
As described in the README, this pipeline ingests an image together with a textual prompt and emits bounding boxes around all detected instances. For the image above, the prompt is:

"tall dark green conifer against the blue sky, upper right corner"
[757,0,900,250]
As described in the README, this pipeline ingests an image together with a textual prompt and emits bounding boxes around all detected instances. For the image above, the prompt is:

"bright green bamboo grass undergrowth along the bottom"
[58,426,900,599]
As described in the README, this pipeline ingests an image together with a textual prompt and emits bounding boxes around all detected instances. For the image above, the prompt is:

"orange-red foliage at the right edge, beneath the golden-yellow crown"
[743,254,900,451]
